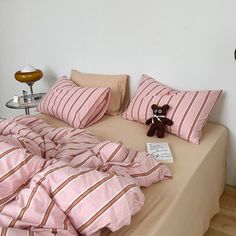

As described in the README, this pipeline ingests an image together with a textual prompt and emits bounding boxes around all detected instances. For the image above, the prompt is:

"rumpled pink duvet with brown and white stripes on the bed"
[0,116,171,236]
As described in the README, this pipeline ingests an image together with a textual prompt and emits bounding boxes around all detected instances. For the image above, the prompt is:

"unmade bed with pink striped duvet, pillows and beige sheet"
[0,71,228,236]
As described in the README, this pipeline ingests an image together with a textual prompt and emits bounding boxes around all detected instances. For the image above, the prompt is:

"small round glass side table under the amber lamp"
[6,93,46,115]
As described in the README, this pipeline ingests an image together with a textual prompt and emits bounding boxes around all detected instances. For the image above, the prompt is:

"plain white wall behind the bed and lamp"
[0,0,236,185]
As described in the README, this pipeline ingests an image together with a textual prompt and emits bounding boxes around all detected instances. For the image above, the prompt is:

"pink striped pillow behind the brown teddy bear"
[122,75,222,144]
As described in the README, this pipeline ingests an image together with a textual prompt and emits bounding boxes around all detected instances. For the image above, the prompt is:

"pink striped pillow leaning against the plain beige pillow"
[38,77,110,128]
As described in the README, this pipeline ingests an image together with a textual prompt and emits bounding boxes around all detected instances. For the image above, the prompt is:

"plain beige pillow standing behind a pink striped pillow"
[71,70,129,115]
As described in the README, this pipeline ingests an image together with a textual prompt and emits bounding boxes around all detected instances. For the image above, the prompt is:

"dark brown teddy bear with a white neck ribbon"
[146,104,173,138]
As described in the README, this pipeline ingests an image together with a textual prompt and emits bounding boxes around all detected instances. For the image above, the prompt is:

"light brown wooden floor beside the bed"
[204,185,236,236]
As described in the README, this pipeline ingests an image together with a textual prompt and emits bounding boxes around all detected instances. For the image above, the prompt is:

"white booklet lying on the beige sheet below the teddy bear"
[147,143,174,163]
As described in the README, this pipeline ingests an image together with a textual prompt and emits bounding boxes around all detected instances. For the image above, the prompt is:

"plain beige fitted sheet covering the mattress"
[37,114,228,236]
